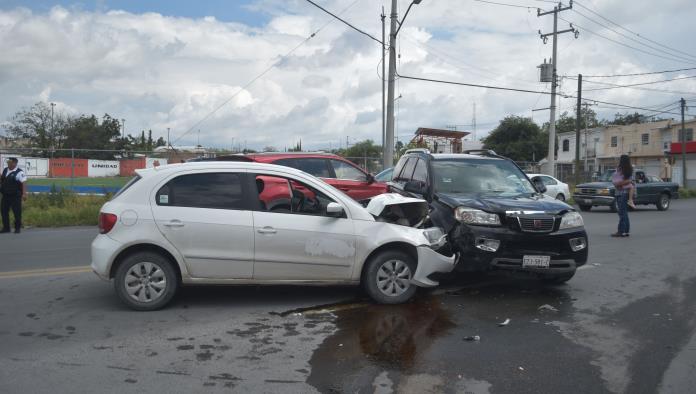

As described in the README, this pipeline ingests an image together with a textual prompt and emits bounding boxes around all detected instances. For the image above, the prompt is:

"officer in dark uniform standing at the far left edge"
[0,157,27,234]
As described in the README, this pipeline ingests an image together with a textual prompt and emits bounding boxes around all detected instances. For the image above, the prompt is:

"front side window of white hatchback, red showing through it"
[256,175,334,216]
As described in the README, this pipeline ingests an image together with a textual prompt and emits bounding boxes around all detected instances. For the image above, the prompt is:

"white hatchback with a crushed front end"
[92,162,455,310]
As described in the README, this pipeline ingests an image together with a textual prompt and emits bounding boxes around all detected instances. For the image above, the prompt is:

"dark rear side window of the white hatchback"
[155,173,247,209]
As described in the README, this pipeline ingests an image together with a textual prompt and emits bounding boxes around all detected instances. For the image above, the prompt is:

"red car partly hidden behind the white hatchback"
[217,152,387,201]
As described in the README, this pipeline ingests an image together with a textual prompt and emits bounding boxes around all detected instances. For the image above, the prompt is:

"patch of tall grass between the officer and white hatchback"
[22,188,110,227]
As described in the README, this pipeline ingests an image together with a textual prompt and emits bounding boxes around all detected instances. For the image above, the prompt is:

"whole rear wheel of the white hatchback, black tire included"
[114,252,179,311]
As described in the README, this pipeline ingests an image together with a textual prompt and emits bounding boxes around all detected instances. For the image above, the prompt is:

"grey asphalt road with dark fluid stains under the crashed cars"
[0,200,696,393]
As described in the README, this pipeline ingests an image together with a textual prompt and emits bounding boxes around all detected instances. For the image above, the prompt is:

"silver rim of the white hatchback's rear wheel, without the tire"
[124,262,167,303]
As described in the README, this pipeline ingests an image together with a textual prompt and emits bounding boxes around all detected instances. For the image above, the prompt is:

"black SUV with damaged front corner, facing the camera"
[389,149,588,283]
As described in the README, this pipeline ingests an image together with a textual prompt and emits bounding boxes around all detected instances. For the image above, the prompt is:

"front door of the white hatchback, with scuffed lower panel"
[253,173,356,280]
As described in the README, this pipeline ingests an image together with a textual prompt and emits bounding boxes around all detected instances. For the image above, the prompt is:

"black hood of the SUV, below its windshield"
[438,194,573,214]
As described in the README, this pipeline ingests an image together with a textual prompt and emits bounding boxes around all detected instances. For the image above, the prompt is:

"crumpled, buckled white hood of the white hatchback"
[366,193,429,227]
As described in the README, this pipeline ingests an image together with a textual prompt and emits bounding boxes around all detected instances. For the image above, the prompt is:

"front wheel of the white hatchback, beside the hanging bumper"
[362,250,417,304]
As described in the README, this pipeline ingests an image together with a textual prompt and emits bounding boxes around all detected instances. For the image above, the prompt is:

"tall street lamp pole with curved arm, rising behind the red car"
[382,0,422,168]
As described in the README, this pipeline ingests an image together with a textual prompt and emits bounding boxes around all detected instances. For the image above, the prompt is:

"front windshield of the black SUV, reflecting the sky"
[432,159,536,196]
